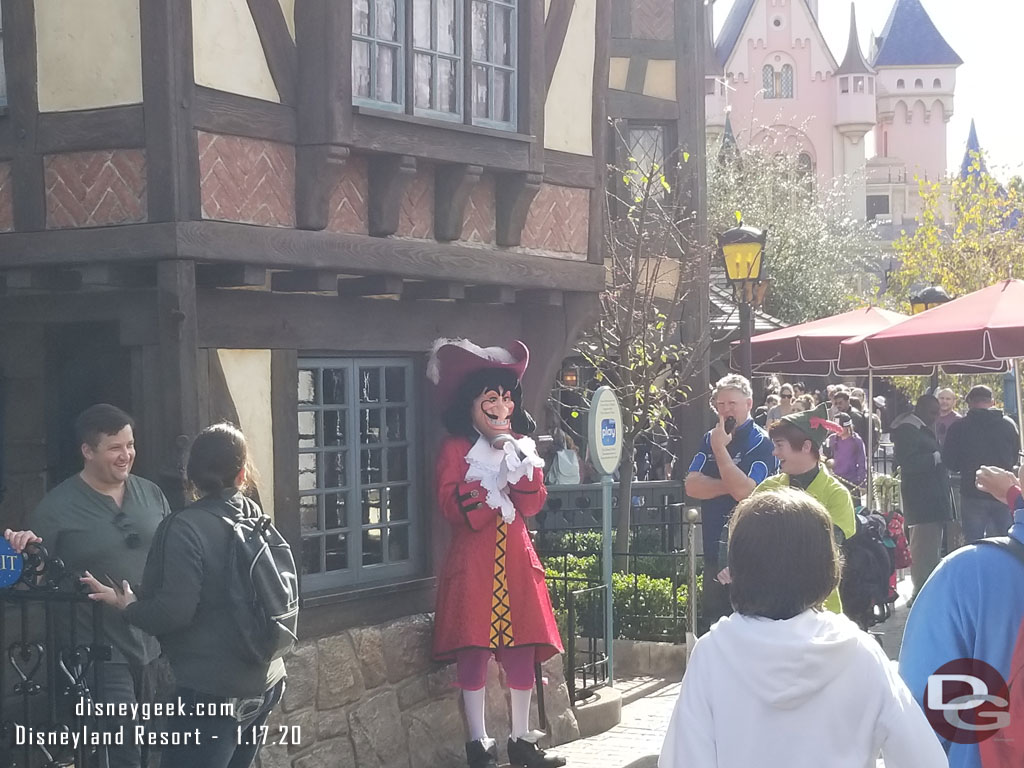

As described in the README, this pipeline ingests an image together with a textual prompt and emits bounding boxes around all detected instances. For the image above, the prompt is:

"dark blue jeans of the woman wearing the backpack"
[160,680,285,768]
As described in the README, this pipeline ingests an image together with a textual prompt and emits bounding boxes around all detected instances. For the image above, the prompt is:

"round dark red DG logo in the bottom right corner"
[925,658,1010,744]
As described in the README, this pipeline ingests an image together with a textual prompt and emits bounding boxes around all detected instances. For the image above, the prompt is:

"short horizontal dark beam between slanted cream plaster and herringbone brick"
[195,86,297,144]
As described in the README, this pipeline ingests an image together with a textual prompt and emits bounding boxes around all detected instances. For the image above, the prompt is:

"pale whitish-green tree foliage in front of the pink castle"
[708,138,881,324]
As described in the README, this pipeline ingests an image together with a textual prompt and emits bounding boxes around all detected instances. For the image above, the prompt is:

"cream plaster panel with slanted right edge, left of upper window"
[191,0,281,102]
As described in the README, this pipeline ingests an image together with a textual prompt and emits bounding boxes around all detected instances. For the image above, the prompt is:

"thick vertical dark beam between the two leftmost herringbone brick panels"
[139,0,202,221]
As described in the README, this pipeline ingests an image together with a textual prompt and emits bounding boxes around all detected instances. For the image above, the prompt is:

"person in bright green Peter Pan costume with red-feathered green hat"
[754,403,857,613]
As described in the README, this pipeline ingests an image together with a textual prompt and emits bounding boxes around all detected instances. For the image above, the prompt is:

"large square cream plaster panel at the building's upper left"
[35,0,142,112]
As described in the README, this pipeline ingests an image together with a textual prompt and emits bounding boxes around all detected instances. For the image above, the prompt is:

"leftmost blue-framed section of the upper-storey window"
[352,0,406,108]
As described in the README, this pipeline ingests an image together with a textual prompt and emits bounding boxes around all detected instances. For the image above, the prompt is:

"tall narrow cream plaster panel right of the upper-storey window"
[544,0,597,156]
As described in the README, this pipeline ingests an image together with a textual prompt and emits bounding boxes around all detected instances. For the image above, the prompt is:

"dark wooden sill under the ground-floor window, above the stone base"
[299,577,437,640]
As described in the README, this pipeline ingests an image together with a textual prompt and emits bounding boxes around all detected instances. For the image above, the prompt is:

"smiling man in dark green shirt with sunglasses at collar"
[4,403,170,768]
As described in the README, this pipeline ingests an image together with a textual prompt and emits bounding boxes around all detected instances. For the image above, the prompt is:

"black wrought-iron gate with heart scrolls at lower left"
[0,548,111,768]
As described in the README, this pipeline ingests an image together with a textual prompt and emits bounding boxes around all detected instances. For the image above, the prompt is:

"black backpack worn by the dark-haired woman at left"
[204,507,299,664]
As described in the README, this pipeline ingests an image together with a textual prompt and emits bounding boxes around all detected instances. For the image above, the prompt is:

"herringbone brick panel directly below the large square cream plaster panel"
[43,150,146,229]
